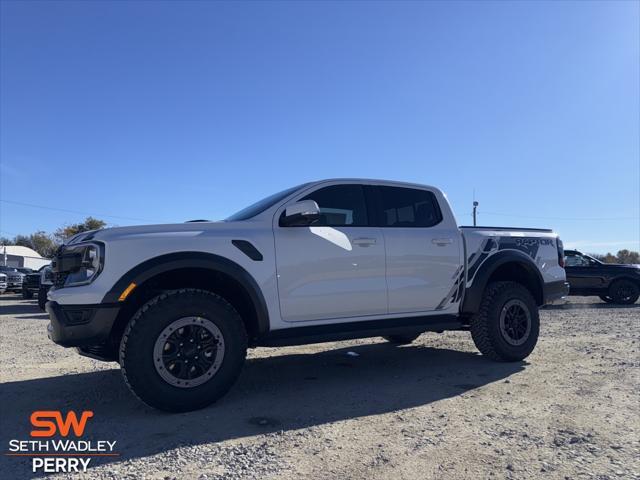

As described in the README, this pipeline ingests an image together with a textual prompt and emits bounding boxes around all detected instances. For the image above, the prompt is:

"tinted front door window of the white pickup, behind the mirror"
[302,185,367,227]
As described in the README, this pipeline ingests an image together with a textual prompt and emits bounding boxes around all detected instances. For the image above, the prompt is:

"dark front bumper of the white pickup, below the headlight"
[45,301,120,347]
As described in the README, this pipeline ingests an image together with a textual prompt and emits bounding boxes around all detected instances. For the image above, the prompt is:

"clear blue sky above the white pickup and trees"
[0,1,640,252]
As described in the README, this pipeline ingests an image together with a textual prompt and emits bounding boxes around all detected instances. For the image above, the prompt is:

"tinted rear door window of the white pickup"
[378,187,442,227]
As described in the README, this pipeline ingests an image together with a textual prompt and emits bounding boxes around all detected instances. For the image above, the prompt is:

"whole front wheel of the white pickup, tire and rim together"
[120,289,247,412]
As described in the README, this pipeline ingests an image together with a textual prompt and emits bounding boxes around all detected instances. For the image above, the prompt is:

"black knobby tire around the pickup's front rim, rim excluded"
[120,289,247,412]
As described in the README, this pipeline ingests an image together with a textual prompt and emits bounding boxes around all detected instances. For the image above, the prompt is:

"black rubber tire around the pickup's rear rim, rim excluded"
[471,282,540,362]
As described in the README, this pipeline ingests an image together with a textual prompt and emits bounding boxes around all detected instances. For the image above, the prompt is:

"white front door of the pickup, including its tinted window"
[274,184,387,322]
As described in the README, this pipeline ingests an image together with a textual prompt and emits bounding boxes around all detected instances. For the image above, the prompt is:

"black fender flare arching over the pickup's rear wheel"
[461,250,544,314]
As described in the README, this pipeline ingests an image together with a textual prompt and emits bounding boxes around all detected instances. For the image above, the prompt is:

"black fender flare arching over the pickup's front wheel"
[102,252,269,343]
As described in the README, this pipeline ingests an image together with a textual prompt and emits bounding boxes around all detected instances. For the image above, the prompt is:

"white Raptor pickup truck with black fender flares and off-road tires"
[46,179,568,411]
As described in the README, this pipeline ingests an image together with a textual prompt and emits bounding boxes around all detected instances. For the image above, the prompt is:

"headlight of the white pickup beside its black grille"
[53,243,104,287]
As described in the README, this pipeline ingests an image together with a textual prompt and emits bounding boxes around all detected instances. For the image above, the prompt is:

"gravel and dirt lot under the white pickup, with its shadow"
[0,294,640,479]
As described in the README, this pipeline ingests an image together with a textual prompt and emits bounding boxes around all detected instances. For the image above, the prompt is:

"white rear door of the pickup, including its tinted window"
[375,186,464,313]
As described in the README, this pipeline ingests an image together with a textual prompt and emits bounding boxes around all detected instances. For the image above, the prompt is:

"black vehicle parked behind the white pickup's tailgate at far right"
[564,250,640,305]
